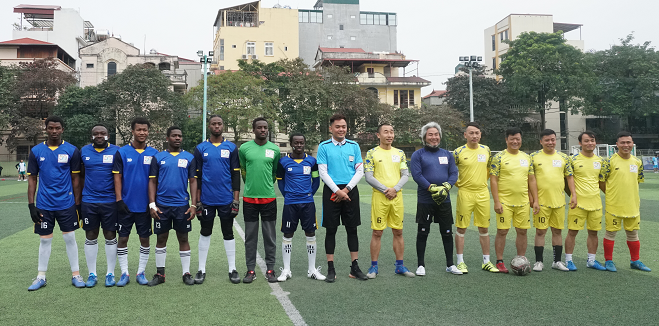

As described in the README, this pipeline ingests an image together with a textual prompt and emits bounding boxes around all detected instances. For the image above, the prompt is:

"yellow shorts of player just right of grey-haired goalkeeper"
[455,189,490,229]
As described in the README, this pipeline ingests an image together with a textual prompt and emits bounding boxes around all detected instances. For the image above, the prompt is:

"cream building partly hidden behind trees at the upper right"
[483,14,596,151]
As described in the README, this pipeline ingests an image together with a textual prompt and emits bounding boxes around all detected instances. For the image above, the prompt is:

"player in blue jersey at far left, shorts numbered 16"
[27,117,85,291]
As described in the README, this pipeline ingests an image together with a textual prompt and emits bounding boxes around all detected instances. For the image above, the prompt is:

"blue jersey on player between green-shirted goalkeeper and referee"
[277,154,320,205]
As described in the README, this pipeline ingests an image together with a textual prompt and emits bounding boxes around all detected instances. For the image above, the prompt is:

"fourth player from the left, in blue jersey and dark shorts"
[148,126,197,286]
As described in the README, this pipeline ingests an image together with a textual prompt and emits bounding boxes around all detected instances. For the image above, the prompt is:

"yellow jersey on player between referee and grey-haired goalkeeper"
[364,146,407,192]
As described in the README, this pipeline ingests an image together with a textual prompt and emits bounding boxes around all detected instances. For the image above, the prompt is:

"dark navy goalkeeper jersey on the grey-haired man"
[410,147,458,204]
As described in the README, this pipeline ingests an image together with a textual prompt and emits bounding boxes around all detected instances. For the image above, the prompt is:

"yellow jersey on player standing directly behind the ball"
[490,150,534,206]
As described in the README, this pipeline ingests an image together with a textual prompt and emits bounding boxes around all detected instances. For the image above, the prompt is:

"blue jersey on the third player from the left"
[112,144,158,213]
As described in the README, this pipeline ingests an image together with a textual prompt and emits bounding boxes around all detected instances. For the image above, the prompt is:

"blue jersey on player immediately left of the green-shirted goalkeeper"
[194,139,240,206]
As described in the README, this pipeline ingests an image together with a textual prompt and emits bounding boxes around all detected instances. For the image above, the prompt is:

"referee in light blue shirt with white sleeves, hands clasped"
[318,113,368,283]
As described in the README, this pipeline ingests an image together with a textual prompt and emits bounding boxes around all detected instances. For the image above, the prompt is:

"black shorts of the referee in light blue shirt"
[322,185,362,228]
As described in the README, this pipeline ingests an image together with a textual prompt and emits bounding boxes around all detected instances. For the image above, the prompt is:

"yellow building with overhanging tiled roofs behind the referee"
[313,47,430,108]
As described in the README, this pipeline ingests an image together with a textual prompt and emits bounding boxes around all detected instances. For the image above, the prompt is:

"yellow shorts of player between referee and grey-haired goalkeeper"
[371,191,405,230]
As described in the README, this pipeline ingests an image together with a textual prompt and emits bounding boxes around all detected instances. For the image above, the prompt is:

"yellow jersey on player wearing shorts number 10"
[531,150,578,208]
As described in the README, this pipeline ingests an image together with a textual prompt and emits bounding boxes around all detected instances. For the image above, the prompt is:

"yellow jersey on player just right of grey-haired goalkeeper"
[453,144,492,192]
